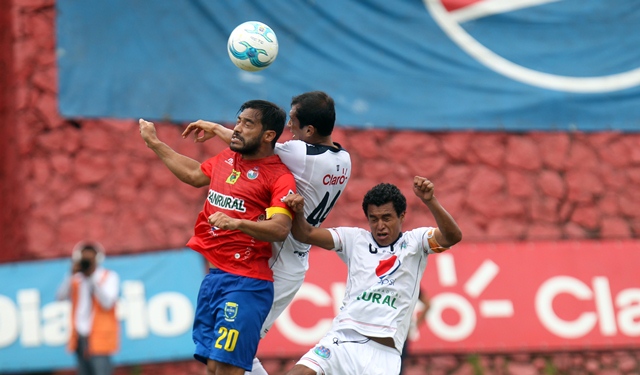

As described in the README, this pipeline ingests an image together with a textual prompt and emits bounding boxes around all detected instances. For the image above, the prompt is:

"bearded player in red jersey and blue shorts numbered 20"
[139,100,296,375]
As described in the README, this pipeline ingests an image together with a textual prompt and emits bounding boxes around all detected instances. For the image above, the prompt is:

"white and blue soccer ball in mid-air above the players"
[227,21,278,72]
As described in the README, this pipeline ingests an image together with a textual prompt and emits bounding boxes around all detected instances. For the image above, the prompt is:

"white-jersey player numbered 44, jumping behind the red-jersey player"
[183,91,351,375]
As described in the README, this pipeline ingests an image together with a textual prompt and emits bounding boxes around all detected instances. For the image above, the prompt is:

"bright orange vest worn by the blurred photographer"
[67,270,120,355]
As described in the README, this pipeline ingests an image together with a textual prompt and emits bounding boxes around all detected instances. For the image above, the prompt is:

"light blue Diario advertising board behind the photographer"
[0,250,205,373]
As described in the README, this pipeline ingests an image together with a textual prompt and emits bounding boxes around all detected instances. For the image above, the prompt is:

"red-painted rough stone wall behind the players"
[0,0,640,261]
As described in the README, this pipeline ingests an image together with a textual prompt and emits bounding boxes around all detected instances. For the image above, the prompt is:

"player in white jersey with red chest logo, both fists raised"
[285,176,462,375]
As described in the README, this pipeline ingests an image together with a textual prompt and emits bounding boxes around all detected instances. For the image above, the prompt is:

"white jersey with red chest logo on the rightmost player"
[329,227,442,352]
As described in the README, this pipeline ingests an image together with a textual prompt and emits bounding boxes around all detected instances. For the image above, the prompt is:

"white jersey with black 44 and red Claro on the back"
[270,140,351,280]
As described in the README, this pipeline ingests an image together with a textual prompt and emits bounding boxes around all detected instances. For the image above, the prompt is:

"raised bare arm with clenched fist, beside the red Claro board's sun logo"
[413,176,462,247]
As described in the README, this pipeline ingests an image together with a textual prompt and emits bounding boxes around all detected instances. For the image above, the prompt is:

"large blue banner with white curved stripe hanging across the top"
[56,0,640,131]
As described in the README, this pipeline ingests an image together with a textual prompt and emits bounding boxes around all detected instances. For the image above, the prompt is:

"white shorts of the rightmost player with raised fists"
[297,330,401,375]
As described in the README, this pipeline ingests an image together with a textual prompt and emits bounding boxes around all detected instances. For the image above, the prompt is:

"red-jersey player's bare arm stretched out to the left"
[138,119,210,187]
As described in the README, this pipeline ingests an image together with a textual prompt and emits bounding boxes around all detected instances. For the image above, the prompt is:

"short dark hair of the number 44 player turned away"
[291,91,336,137]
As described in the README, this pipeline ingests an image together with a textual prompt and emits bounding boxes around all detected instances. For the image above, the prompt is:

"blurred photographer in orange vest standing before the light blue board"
[56,242,120,375]
